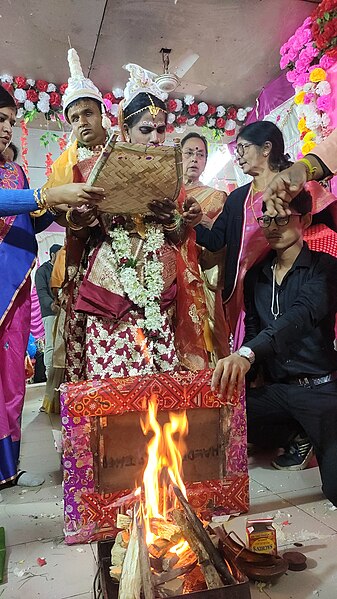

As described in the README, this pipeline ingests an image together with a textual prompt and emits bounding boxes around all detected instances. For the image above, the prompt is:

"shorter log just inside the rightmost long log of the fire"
[173,510,225,589]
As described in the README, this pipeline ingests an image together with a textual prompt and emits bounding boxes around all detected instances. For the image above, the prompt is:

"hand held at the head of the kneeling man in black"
[263,162,307,216]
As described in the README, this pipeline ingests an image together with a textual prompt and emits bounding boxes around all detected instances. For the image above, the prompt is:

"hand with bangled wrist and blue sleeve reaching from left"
[45,183,105,210]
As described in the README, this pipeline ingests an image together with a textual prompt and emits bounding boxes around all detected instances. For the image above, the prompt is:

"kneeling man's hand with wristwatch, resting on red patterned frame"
[211,353,250,401]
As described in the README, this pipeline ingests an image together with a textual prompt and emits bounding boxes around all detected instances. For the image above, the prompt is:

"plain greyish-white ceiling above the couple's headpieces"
[0,0,315,105]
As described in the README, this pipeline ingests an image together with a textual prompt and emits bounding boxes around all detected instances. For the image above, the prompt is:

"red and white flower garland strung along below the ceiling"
[0,74,252,138]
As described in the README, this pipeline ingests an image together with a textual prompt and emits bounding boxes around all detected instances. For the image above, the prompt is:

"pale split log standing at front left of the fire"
[118,521,142,599]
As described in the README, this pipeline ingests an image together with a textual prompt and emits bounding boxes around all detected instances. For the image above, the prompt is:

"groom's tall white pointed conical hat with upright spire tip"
[62,48,105,118]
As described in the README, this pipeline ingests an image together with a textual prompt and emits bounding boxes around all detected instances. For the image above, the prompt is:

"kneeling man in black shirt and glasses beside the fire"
[212,191,337,505]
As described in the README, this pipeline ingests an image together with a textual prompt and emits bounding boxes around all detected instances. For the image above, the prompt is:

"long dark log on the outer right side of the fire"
[173,485,236,588]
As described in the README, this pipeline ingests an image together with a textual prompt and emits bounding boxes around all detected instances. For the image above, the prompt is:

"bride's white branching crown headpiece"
[123,63,167,109]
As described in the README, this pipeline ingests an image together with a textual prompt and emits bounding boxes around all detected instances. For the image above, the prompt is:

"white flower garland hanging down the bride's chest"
[110,225,165,332]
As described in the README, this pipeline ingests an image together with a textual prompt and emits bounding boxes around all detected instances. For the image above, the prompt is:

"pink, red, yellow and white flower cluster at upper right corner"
[280,0,337,155]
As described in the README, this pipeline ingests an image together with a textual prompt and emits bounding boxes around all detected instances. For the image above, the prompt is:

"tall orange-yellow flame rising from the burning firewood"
[141,395,188,551]
